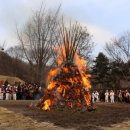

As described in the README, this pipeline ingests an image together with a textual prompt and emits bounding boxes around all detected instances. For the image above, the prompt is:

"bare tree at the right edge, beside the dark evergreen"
[105,32,130,62]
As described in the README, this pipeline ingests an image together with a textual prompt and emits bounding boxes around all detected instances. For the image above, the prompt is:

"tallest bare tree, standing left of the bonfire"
[17,6,60,82]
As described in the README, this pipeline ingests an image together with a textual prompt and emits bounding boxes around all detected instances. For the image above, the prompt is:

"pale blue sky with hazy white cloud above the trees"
[0,0,130,56]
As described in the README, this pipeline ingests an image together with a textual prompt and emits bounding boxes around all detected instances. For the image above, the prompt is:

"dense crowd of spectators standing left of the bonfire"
[0,81,42,100]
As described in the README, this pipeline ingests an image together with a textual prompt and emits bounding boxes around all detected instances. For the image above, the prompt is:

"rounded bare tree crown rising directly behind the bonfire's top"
[53,18,94,66]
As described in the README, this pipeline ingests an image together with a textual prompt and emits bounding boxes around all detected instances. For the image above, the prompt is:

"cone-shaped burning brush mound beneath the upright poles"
[39,63,91,110]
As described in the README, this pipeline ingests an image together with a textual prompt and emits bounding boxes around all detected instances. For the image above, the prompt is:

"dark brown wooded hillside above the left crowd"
[0,51,30,81]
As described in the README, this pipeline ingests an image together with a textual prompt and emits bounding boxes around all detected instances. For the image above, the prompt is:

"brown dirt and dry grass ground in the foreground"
[0,101,130,130]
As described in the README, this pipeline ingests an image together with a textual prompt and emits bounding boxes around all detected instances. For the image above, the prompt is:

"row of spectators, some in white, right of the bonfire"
[92,90,130,103]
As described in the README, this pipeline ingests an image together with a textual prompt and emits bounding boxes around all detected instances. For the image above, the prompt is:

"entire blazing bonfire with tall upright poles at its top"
[37,23,92,110]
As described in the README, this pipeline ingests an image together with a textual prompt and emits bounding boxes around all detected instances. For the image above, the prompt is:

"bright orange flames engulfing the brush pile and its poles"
[42,48,91,110]
